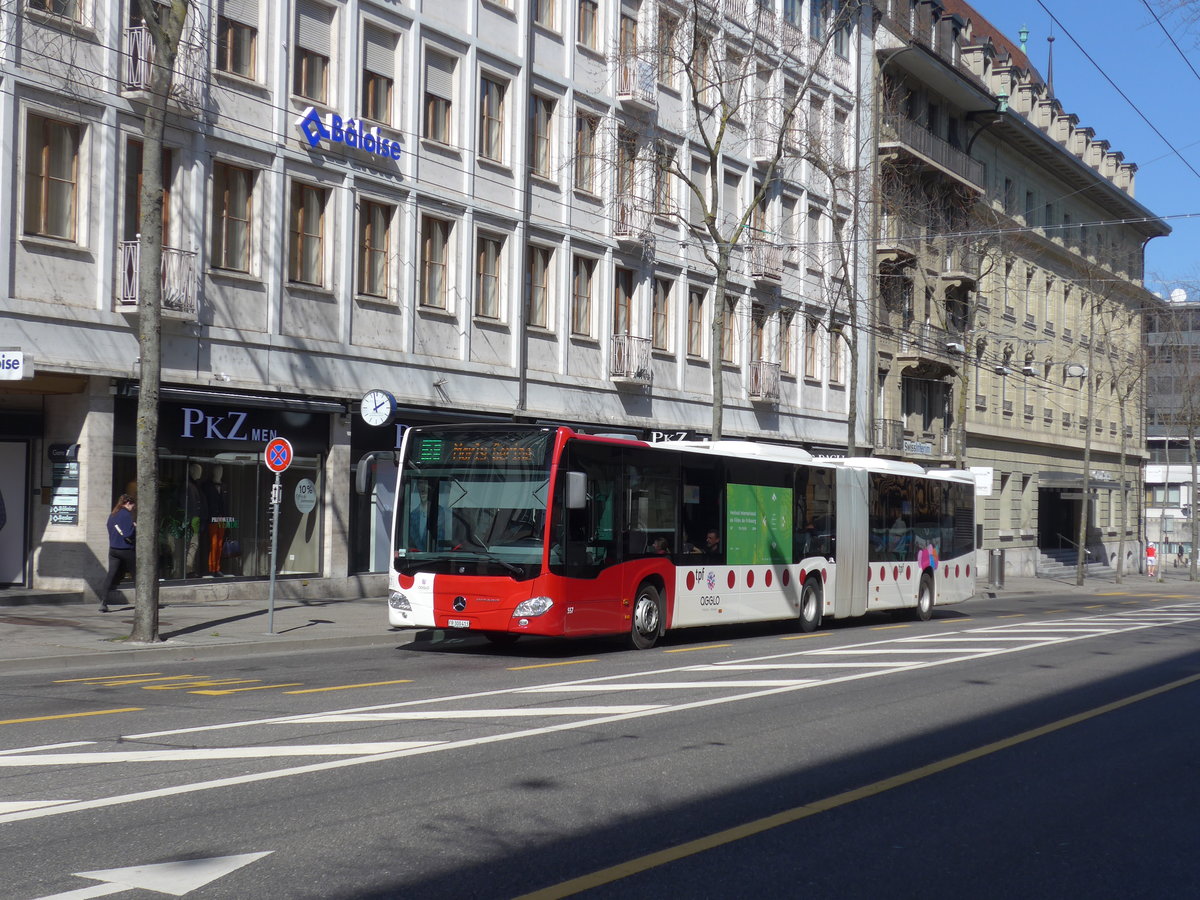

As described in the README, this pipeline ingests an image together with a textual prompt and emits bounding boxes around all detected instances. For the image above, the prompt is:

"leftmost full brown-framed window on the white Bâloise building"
[25,115,79,241]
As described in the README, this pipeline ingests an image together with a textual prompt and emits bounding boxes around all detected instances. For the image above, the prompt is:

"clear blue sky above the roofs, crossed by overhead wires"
[968,0,1200,298]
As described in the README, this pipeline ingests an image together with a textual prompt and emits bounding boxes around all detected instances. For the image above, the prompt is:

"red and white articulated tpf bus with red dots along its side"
[388,425,976,649]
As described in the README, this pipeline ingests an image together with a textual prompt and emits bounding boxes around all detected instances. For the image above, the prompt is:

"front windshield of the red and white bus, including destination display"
[395,428,554,578]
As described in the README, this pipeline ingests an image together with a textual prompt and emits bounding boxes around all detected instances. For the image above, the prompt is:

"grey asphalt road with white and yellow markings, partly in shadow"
[0,588,1200,900]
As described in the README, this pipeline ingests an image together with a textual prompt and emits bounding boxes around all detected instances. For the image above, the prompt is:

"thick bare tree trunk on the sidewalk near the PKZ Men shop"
[131,0,188,642]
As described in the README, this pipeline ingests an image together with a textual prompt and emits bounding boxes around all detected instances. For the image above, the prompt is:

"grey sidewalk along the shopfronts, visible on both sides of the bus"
[0,568,1200,672]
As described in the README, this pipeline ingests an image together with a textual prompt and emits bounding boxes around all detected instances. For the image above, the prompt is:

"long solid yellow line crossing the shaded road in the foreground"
[517,673,1200,900]
